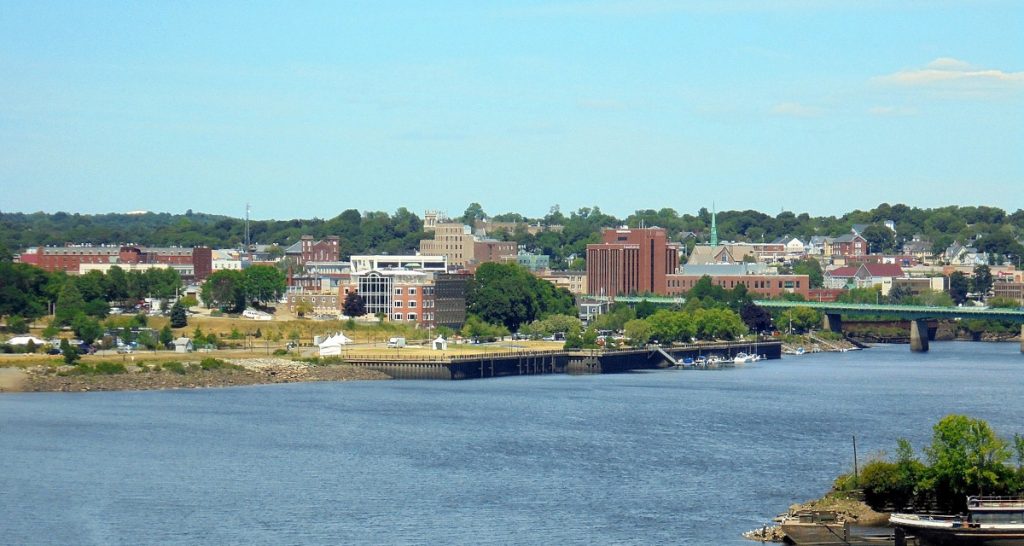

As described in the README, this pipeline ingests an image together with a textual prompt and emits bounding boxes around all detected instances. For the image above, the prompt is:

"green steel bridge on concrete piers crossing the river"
[593,296,1024,352]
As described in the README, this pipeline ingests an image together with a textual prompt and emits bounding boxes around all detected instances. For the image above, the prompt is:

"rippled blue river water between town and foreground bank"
[0,343,1024,544]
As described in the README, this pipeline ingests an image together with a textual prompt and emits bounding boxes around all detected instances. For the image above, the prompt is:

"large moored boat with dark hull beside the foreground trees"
[889,496,1024,546]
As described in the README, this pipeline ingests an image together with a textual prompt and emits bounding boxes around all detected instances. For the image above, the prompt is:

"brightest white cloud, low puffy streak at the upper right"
[874,57,1024,91]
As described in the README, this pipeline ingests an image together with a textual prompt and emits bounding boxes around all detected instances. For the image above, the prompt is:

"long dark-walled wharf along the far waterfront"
[345,341,782,380]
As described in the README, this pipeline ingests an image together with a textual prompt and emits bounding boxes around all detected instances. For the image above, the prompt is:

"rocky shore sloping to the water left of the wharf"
[0,359,390,392]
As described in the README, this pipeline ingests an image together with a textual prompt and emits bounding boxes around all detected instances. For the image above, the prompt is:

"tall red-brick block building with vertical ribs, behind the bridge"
[587,227,680,296]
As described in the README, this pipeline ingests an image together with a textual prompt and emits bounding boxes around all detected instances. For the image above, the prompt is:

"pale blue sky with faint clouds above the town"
[0,0,1024,219]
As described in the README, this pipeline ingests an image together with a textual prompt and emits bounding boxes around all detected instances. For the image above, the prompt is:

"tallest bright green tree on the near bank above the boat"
[925,415,1011,513]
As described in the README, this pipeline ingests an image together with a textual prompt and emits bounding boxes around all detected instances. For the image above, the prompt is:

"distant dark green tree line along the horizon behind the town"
[9,203,1024,268]
